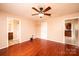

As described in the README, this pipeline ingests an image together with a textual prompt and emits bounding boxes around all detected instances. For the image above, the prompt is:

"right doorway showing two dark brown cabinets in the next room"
[65,18,79,46]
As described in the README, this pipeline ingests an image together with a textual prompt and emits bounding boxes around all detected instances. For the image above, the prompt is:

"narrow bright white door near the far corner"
[41,21,47,39]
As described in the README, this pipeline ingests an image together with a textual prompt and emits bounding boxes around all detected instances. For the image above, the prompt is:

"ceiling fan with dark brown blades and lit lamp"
[32,6,51,18]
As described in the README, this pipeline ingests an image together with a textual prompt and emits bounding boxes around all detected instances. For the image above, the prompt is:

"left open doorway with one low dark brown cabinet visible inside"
[7,17,21,46]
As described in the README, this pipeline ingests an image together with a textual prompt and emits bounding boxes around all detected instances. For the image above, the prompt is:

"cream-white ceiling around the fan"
[0,3,79,20]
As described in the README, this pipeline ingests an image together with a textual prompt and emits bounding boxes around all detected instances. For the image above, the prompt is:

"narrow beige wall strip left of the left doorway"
[0,12,8,49]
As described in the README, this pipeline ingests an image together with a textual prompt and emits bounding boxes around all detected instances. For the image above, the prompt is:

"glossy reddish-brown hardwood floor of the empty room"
[0,39,79,56]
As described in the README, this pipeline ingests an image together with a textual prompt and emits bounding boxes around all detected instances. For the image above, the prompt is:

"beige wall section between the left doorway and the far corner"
[21,19,36,42]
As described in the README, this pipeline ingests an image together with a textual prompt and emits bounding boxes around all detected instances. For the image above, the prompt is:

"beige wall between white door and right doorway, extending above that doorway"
[48,13,79,43]
